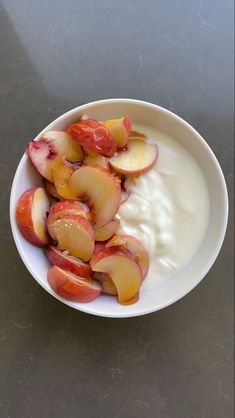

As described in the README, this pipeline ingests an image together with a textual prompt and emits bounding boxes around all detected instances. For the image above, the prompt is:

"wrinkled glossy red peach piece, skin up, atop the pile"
[67,119,117,157]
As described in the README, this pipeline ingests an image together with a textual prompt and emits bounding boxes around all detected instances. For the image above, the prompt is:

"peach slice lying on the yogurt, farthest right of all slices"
[109,139,158,176]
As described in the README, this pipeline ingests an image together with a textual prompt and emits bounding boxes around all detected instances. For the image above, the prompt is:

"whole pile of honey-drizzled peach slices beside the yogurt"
[16,115,158,305]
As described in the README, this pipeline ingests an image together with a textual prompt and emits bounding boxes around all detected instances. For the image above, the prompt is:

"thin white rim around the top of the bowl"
[9,98,229,318]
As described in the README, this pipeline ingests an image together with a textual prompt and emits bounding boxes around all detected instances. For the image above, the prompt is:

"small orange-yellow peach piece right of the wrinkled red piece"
[103,116,131,148]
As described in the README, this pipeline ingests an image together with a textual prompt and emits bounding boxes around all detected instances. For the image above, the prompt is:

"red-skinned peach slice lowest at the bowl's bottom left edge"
[47,266,102,302]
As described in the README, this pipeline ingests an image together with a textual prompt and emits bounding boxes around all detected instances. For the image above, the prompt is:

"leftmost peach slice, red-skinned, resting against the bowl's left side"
[16,187,49,247]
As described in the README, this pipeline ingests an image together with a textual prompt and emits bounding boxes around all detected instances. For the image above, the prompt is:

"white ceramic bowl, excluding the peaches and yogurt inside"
[10,99,228,318]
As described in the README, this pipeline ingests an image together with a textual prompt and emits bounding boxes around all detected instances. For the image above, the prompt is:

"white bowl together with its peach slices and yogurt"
[10,99,227,317]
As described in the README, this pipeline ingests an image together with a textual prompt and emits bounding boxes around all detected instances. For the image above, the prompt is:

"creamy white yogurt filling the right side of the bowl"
[118,126,210,289]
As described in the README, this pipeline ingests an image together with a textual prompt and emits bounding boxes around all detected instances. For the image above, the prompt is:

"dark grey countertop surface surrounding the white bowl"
[0,0,233,418]
